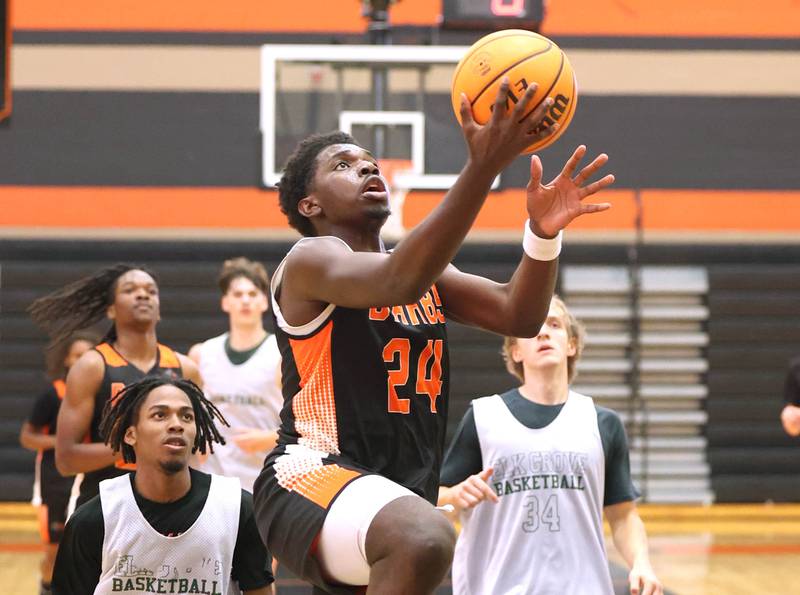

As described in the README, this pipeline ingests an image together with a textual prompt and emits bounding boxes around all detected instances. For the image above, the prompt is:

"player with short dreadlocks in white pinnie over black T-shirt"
[53,376,273,595]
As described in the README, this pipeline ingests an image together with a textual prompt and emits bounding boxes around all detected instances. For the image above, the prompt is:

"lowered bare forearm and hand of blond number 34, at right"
[604,500,664,595]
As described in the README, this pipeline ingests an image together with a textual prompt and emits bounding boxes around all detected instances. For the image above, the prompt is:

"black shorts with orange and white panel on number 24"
[253,446,372,595]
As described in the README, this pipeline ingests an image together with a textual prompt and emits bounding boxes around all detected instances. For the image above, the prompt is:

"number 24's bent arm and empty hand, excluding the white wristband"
[437,145,614,337]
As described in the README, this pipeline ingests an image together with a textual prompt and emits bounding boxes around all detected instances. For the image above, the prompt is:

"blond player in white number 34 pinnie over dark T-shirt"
[439,298,662,595]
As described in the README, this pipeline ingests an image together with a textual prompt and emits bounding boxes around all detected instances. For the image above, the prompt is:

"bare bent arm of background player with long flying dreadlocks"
[56,351,116,475]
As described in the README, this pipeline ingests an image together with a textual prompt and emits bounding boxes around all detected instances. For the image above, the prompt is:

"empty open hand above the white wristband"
[528,145,614,238]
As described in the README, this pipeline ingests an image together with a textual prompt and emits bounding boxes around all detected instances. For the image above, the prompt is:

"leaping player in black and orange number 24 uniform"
[255,78,614,595]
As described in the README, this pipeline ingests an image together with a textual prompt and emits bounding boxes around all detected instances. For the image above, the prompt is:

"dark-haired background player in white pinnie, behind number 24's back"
[189,258,283,492]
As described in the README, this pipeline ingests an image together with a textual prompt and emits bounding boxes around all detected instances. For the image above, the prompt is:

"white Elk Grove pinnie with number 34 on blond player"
[453,392,614,595]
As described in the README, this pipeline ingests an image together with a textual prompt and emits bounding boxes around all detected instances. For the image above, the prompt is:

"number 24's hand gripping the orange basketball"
[460,76,558,176]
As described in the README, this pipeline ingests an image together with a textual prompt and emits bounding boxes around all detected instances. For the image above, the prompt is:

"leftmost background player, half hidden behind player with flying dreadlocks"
[19,333,97,595]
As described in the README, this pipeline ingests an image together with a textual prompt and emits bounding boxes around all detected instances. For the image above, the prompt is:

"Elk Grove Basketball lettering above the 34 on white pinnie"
[492,451,588,497]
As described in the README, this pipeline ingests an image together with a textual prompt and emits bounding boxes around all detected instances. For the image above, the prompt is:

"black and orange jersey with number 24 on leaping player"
[272,240,449,502]
